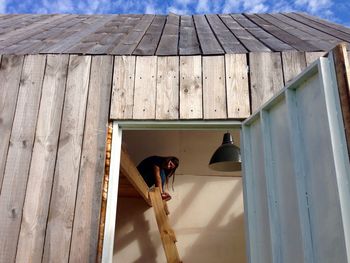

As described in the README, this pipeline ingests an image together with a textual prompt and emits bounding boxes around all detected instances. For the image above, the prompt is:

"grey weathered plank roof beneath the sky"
[0,13,350,56]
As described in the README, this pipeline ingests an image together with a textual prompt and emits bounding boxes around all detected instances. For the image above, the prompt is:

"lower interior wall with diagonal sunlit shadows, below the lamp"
[113,175,246,263]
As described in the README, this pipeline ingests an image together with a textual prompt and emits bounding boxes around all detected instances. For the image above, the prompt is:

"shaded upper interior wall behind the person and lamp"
[123,129,241,176]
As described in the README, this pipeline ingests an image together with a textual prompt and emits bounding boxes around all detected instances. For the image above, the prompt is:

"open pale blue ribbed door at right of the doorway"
[241,54,350,263]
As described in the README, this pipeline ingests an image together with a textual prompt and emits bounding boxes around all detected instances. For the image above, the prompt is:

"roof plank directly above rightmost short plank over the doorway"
[206,15,247,53]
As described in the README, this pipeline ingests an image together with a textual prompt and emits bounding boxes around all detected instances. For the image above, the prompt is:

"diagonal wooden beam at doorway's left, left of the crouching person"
[120,149,152,206]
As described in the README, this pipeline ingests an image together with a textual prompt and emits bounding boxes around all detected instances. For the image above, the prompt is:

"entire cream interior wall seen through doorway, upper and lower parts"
[113,131,246,263]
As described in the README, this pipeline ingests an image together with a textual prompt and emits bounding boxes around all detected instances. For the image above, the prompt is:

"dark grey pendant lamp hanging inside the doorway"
[209,132,241,172]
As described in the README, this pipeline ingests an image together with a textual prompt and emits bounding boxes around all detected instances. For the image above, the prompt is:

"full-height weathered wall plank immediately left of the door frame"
[69,56,113,262]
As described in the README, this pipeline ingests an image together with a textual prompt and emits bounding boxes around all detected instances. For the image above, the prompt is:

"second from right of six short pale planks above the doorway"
[203,56,227,119]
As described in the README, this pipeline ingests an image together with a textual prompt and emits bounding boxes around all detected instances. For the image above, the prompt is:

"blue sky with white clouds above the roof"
[0,0,350,26]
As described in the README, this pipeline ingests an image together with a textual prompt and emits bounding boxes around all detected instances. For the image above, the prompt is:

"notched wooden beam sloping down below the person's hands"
[149,187,181,263]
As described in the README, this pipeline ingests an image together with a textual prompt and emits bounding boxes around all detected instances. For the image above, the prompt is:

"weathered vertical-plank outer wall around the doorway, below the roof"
[0,50,322,262]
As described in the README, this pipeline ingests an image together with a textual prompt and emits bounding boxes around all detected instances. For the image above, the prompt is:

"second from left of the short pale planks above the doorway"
[133,56,157,119]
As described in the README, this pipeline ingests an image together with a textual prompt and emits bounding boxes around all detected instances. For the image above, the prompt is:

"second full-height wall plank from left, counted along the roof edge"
[0,55,46,262]
